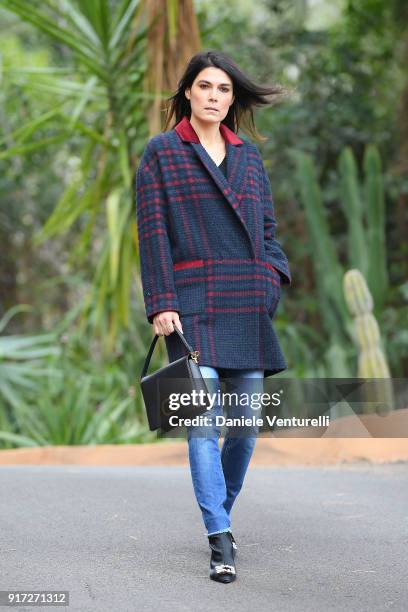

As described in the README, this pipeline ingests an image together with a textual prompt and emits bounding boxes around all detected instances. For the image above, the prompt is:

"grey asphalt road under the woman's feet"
[0,463,408,612]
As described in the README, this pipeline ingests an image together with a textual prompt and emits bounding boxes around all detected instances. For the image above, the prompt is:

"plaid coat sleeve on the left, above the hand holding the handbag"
[136,142,180,323]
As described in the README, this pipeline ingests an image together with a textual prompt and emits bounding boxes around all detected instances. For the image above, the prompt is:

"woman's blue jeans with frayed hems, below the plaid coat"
[186,365,264,535]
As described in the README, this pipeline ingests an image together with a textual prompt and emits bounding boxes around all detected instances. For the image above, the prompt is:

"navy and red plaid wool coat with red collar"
[136,112,291,377]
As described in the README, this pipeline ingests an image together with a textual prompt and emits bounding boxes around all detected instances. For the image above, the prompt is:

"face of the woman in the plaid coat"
[185,66,234,123]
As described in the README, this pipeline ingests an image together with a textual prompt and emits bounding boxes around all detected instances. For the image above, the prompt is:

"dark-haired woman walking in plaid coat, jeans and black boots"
[136,51,291,583]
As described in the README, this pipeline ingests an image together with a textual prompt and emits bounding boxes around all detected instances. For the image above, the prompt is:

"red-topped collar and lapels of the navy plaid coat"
[175,117,255,253]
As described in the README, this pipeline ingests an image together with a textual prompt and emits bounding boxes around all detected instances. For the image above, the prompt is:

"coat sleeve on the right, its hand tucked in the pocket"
[261,159,292,285]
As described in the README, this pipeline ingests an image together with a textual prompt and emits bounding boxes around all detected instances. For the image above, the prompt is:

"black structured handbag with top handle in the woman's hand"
[140,326,210,432]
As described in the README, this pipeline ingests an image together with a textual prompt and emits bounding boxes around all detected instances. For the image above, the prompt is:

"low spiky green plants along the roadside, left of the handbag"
[0,304,159,448]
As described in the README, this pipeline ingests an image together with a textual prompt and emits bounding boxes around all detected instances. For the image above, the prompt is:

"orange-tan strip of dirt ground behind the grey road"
[0,409,408,466]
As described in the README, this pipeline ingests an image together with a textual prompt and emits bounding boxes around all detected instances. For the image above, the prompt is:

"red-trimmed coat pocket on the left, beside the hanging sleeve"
[173,259,205,315]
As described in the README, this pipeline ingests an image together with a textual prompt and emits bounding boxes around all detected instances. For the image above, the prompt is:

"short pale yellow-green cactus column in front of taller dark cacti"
[343,270,393,412]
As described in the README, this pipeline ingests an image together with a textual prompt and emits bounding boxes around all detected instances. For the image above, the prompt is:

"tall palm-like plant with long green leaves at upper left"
[0,0,146,352]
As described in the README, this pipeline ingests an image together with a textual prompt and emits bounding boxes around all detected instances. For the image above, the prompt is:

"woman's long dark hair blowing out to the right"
[164,51,287,140]
